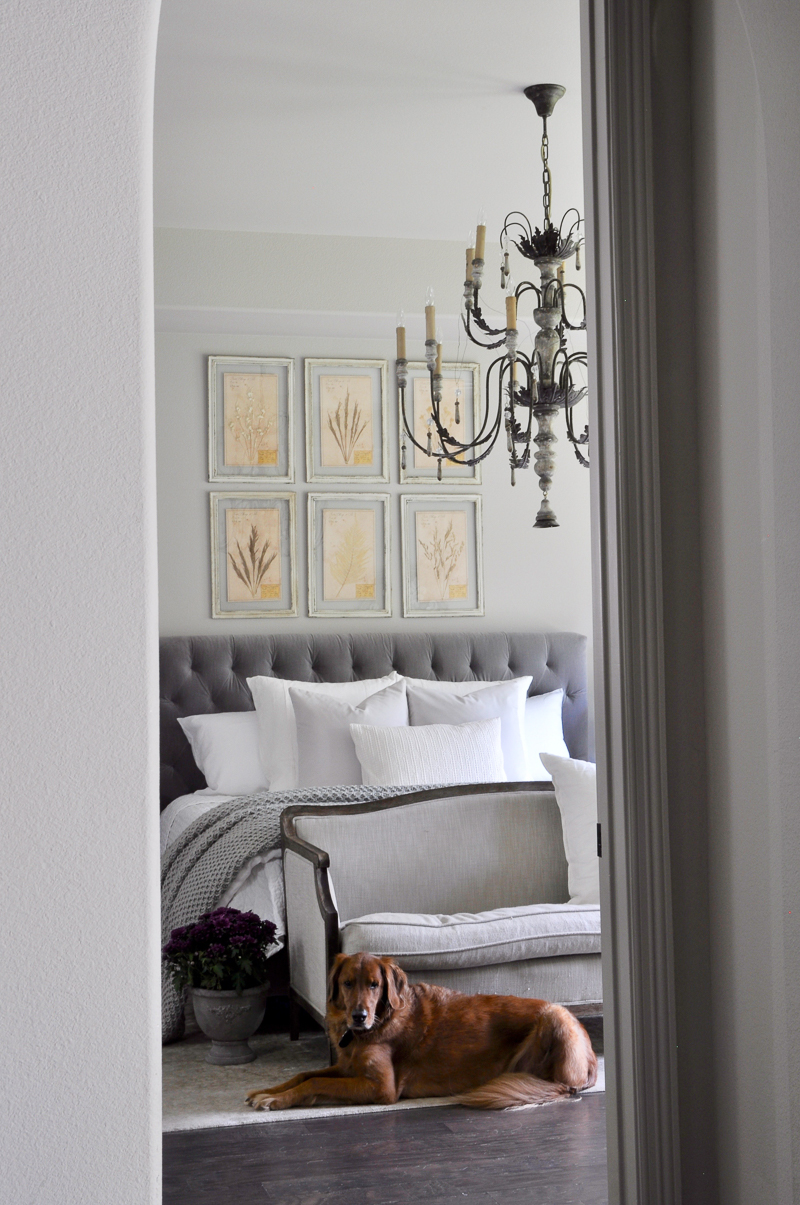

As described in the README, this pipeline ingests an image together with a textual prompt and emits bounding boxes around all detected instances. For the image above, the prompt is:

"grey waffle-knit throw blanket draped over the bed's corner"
[161,786,420,1042]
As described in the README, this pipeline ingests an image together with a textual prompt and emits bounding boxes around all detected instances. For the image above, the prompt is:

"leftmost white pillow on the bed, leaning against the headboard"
[178,711,270,795]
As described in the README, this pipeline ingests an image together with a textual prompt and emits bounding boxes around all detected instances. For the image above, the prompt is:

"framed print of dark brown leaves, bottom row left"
[210,493,298,619]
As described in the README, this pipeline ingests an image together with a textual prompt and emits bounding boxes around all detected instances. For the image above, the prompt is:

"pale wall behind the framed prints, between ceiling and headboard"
[155,227,592,635]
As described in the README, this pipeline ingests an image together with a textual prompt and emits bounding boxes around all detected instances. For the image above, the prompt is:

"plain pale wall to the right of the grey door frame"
[694,0,800,1205]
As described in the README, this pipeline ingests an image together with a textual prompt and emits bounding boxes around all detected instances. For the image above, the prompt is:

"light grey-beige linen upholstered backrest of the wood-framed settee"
[295,790,569,922]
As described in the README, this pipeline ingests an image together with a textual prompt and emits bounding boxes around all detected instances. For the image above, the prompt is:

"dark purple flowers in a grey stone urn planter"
[161,907,275,1065]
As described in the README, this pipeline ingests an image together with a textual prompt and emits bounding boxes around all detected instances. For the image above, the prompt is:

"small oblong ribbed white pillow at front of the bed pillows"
[351,719,506,787]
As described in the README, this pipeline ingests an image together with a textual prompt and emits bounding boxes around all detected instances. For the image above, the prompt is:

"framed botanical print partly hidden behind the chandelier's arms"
[398,363,482,486]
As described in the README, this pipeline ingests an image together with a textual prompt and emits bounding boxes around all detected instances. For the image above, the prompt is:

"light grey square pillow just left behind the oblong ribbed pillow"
[289,678,408,787]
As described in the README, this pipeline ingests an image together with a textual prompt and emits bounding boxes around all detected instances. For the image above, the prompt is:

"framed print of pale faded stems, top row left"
[208,355,294,484]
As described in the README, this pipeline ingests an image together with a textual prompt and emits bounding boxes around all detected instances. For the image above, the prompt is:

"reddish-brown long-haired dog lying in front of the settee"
[247,953,598,1109]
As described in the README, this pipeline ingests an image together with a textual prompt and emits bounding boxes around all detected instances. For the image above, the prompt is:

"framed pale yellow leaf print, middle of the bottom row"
[308,494,392,618]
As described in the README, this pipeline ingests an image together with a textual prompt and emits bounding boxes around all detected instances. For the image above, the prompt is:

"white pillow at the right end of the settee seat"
[541,753,600,904]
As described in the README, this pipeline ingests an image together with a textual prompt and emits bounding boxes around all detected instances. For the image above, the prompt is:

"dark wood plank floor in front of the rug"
[163,1094,608,1205]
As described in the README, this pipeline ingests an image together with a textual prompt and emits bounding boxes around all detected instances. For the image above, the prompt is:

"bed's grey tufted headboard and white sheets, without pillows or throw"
[160,633,588,1036]
